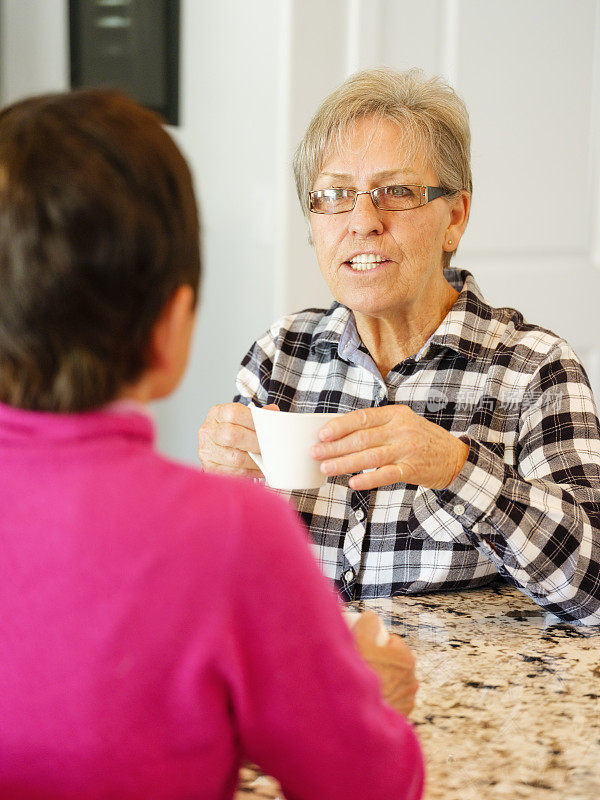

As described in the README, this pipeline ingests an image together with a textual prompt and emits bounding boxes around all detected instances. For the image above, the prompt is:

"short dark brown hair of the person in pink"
[0,89,200,412]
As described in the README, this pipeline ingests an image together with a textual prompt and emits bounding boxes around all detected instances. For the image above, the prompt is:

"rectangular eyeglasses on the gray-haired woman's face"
[308,184,452,214]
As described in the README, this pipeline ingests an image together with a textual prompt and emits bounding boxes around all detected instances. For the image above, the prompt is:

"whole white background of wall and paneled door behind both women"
[0,0,600,463]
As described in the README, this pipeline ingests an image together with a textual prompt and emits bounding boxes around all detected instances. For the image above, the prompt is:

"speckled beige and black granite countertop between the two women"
[236,585,600,800]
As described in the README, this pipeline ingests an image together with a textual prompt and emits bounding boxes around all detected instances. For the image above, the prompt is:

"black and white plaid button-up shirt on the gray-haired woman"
[235,269,600,624]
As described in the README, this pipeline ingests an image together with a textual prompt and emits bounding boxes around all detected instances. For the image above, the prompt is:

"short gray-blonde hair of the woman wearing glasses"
[293,69,473,266]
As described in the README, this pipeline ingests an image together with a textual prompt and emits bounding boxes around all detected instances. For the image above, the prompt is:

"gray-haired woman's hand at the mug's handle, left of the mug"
[198,403,277,478]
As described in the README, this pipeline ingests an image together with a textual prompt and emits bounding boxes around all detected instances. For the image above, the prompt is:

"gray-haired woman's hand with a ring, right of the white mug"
[312,405,469,489]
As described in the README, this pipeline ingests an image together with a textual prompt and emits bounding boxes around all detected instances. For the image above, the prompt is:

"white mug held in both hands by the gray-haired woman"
[248,406,342,491]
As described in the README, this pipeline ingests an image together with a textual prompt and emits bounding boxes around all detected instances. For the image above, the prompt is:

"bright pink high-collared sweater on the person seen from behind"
[0,406,423,800]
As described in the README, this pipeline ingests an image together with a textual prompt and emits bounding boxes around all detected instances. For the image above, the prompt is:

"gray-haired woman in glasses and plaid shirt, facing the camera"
[200,71,600,624]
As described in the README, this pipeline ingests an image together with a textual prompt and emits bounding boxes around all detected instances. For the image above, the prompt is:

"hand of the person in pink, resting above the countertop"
[352,611,419,716]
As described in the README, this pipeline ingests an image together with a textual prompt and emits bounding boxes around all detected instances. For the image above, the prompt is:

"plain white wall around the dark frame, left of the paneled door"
[0,0,285,463]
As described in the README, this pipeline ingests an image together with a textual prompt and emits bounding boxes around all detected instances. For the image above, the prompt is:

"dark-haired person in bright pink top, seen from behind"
[0,91,423,800]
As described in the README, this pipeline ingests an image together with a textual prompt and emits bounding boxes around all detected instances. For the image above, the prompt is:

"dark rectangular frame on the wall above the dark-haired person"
[69,0,180,125]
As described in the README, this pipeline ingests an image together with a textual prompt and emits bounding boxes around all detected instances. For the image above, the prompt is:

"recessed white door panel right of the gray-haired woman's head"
[456,0,599,255]
